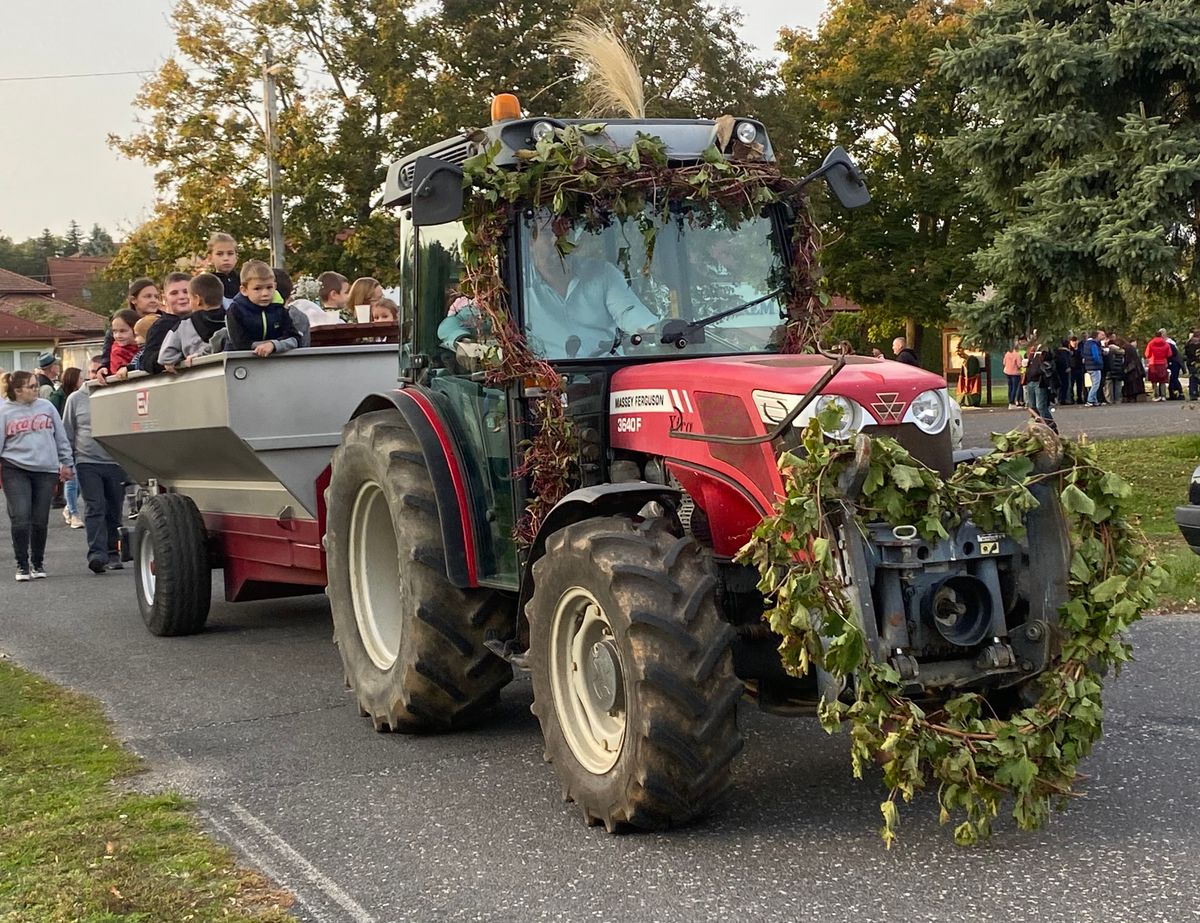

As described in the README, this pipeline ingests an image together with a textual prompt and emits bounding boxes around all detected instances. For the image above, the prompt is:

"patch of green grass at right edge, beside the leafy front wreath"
[1096,434,1200,612]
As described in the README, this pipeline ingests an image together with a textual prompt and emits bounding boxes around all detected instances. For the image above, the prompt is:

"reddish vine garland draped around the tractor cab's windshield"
[461,124,828,546]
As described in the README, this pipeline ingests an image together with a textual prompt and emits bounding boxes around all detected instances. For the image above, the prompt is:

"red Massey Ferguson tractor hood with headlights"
[608,355,955,547]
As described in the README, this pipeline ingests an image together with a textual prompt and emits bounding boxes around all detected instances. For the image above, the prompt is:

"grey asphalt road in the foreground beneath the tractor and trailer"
[0,513,1200,923]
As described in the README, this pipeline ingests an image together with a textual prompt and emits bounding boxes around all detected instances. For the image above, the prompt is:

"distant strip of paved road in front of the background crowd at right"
[962,401,1200,448]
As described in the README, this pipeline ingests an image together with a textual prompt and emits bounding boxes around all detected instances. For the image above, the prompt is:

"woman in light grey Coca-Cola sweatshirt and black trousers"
[0,372,74,582]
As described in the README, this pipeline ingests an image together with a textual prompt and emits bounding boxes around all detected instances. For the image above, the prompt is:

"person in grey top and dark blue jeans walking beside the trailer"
[62,355,127,574]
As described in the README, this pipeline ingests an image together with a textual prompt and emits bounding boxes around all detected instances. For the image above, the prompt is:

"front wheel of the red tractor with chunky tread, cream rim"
[527,517,743,832]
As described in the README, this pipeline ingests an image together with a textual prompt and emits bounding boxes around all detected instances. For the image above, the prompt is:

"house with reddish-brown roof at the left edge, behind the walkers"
[0,269,107,371]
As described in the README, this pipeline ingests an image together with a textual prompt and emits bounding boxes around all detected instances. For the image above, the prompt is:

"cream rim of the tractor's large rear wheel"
[349,481,403,670]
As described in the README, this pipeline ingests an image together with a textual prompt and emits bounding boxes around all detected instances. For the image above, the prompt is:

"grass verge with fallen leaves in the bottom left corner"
[0,660,294,923]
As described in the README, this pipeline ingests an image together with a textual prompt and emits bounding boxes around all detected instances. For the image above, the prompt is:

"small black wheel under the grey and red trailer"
[134,493,212,636]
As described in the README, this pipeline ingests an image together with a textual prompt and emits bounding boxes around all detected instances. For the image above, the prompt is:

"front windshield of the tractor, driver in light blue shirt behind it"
[520,202,786,359]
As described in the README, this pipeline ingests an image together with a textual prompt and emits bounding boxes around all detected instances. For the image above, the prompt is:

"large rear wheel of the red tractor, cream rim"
[325,410,514,732]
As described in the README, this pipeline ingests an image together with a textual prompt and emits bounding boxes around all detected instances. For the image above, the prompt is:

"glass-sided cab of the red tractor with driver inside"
[384,100,865,589]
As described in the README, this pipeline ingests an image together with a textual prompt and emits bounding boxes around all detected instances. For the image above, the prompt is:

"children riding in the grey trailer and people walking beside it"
[0,233,397,582]
